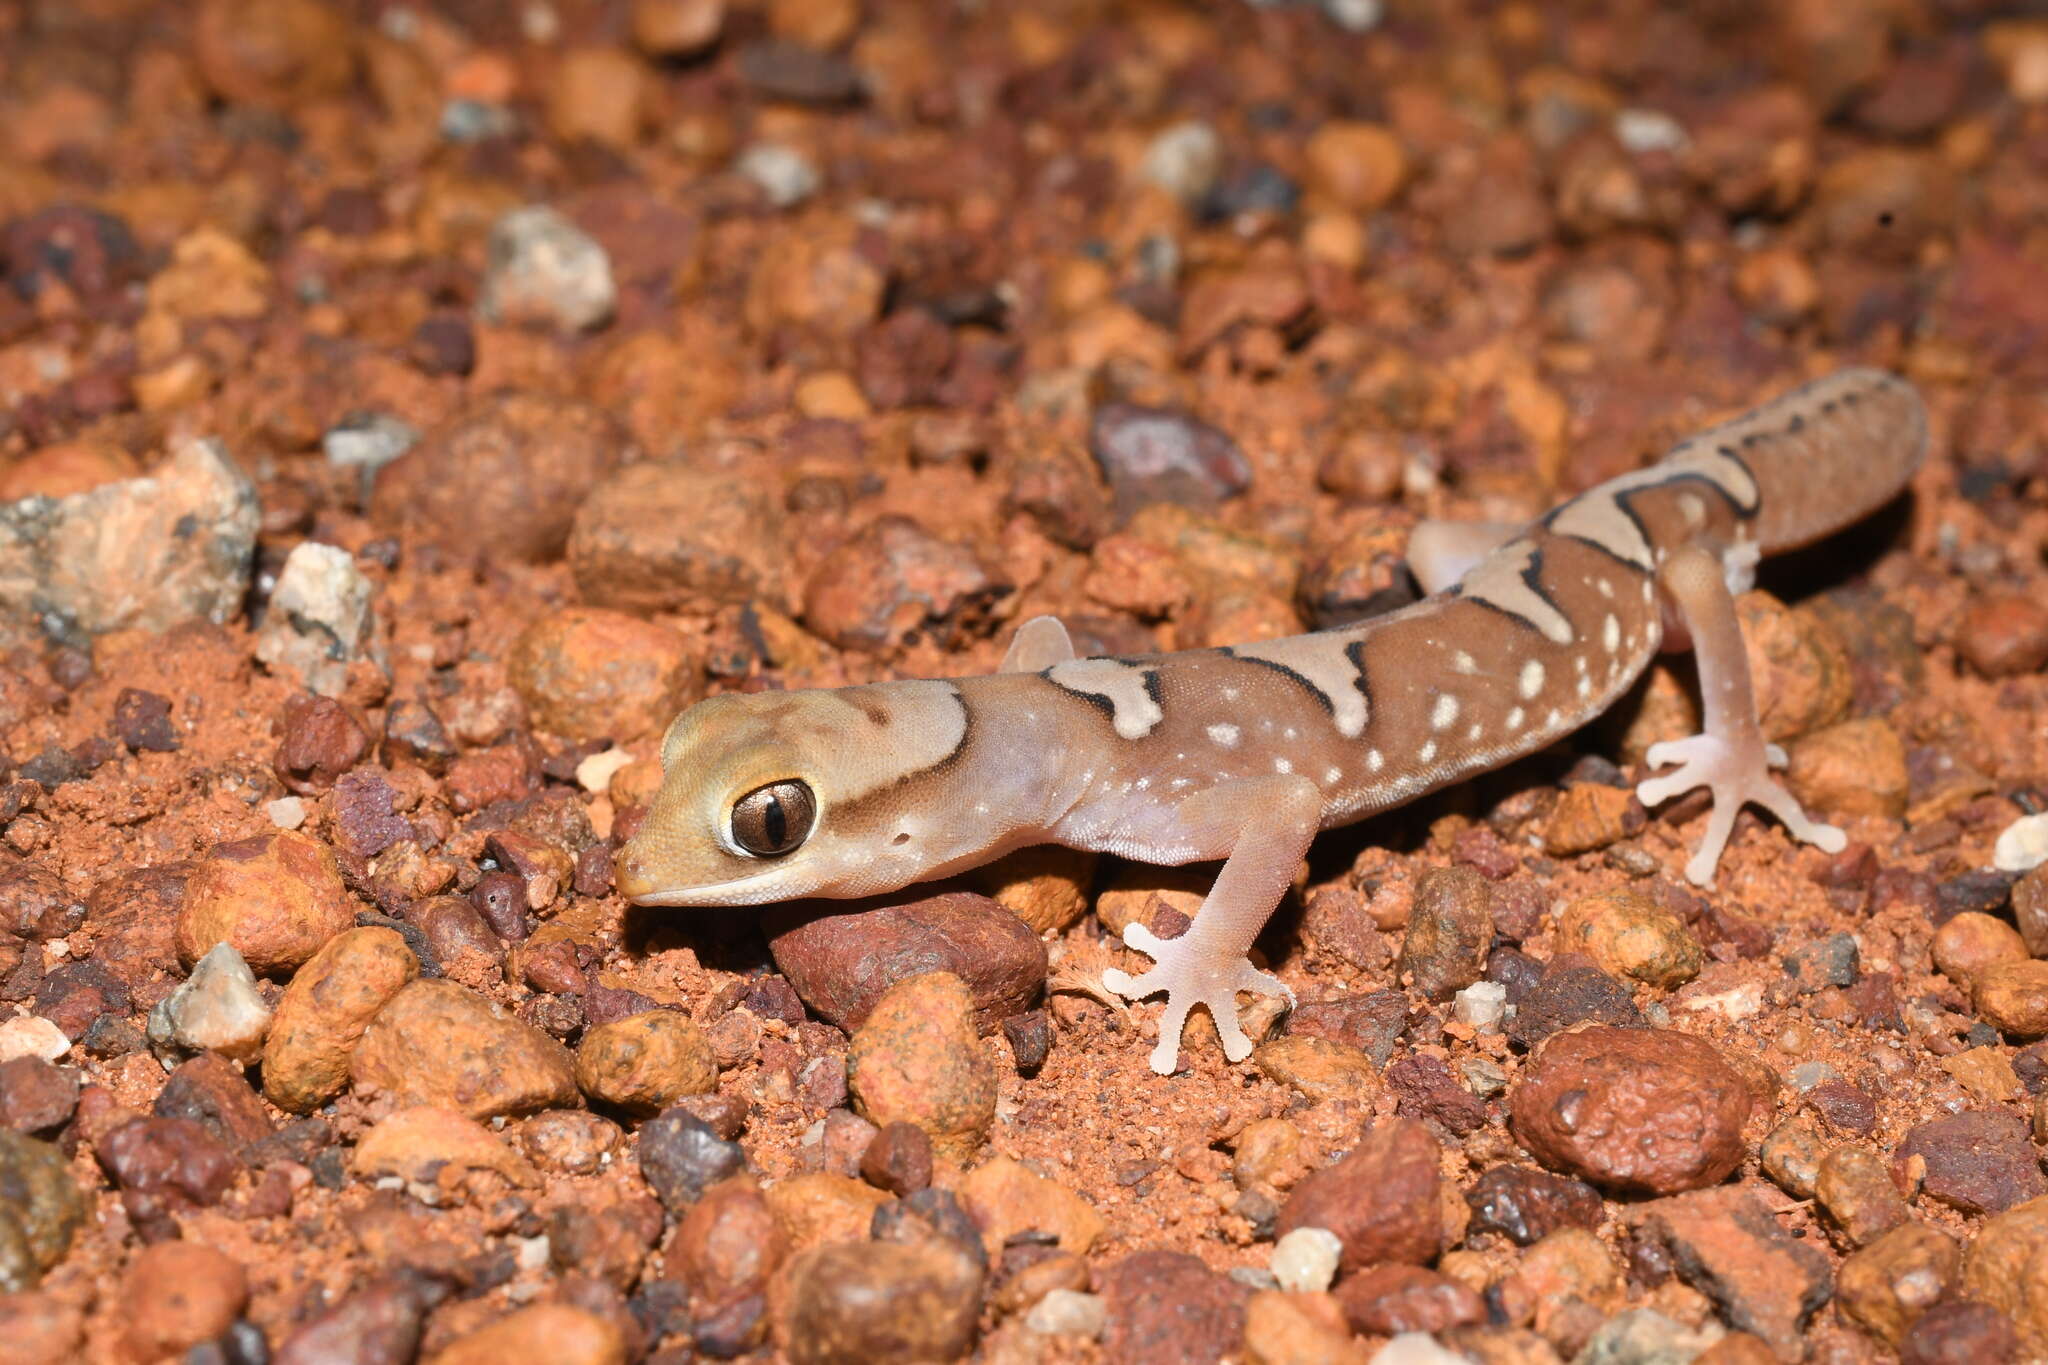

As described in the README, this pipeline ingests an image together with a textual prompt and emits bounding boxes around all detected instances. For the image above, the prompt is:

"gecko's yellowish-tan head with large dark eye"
[618,681,967,905]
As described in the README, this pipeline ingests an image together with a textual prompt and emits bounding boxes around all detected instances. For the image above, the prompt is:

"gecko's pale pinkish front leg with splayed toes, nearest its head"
[1102,776,1323,1076]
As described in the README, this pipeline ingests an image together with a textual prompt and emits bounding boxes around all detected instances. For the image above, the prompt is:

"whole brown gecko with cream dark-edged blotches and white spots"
[616,368,1927,1074]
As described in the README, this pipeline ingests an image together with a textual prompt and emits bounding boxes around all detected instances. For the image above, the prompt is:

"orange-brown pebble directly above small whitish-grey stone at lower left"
[178,829,356,976]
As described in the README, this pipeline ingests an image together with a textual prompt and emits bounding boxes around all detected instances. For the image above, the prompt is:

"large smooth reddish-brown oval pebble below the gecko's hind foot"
[1507,1025,1753,1195]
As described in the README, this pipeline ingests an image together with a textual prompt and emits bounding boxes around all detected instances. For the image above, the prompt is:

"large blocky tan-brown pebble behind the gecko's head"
[569,460,788,614]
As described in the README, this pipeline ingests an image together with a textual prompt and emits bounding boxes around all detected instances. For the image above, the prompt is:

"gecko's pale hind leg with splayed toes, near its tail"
[1636,544,1847,886]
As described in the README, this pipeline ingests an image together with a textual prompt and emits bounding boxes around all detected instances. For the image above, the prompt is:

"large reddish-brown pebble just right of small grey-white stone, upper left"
[371,393,631,561]
